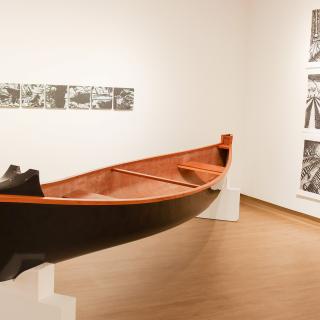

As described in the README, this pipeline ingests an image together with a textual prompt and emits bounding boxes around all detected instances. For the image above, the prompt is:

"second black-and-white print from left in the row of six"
[21,84,44,108]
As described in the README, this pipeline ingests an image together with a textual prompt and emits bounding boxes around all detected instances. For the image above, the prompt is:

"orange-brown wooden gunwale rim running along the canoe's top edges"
[0,136,232,206]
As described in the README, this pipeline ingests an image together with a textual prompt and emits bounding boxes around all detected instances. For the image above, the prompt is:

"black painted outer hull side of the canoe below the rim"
[0,189,219,281]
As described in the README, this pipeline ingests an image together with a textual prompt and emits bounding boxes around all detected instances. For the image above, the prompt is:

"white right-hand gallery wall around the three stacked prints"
[242,0,320,217]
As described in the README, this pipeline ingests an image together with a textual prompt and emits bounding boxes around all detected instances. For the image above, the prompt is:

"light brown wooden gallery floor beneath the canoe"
[56,198,320,320]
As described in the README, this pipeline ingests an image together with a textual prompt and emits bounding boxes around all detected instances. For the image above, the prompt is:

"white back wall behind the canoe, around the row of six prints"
[0,0,248,185]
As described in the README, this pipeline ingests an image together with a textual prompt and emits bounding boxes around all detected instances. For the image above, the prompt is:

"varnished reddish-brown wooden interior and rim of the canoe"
[0,134,233,206]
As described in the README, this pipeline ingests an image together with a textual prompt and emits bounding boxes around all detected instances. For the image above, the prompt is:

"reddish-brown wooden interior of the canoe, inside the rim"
[42,144,229,200]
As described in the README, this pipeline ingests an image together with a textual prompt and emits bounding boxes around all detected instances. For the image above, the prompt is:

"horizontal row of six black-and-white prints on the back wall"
[0,83,134,111]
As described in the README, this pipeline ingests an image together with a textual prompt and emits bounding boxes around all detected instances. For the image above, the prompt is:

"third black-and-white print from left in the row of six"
[46,85,68,109]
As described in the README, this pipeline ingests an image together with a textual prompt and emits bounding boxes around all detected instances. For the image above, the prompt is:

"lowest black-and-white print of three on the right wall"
[300,140,320,194]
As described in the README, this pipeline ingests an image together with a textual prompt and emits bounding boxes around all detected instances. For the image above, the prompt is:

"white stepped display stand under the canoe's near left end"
[0,263,76,320]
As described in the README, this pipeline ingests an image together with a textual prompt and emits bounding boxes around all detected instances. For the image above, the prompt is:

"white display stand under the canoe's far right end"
[198,177,240,221]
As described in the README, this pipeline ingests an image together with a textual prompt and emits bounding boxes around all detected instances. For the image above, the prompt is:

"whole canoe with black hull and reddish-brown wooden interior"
[0,134,232,281]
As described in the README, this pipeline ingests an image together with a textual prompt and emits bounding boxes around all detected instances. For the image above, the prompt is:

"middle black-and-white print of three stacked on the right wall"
[304,74,320,129]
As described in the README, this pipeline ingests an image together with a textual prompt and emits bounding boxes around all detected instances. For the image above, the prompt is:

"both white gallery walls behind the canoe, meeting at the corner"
[0,0,320,216]
